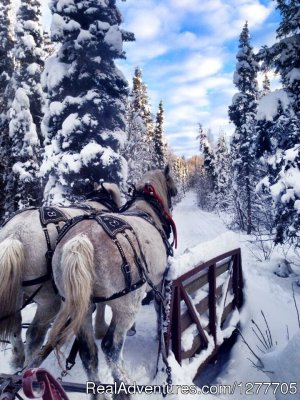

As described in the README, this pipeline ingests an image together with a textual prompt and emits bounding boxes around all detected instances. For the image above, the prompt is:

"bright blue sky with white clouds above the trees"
[43,0,279,157]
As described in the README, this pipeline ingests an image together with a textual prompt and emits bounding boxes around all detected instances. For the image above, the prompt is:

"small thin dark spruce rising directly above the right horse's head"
[153,101,167,169]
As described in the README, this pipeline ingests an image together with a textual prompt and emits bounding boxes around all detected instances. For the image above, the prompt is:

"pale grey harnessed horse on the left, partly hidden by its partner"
[0,183,120,368]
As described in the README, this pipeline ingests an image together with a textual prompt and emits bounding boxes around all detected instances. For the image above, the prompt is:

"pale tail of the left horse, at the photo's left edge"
[0,237,25,343]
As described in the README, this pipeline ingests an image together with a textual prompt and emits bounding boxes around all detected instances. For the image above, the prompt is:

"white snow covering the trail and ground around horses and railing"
[0,192,300,400]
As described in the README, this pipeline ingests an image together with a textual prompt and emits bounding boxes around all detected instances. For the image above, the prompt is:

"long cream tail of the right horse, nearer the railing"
[48,235,95,349]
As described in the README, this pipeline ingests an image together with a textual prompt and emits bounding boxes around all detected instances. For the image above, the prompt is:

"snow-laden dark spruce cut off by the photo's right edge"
[258,0,300,246]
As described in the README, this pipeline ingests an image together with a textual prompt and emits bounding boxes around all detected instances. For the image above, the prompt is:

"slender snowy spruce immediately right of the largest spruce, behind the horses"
[124,67,154,182]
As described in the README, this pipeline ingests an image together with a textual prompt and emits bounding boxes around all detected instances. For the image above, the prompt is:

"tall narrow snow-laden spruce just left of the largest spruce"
[4,0,44,214]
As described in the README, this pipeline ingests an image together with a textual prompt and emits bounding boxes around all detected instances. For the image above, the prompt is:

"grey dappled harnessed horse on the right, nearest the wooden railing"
[46,167,177,398]
